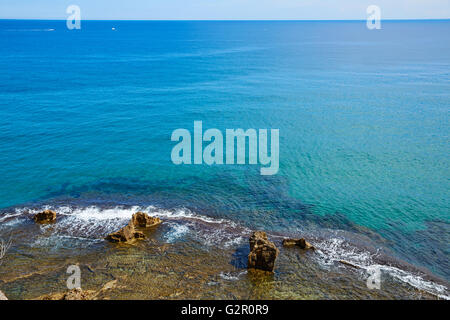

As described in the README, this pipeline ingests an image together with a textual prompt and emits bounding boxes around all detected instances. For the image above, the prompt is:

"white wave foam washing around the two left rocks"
[6,206,249,247]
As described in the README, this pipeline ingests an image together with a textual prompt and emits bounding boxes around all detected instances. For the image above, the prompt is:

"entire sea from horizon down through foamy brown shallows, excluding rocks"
[0,20,450,299]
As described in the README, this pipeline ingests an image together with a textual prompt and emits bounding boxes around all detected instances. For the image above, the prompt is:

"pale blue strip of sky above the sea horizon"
[0,0,450,20]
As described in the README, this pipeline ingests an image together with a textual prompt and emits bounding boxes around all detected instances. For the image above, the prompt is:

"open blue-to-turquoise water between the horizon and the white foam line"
[0,20,450,280]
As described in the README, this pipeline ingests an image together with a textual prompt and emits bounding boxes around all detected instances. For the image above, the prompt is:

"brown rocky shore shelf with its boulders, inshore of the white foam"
[0,210,446,300]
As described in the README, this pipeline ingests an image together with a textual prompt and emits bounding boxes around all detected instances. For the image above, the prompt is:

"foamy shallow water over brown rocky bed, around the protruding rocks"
[0,206,449,299]
